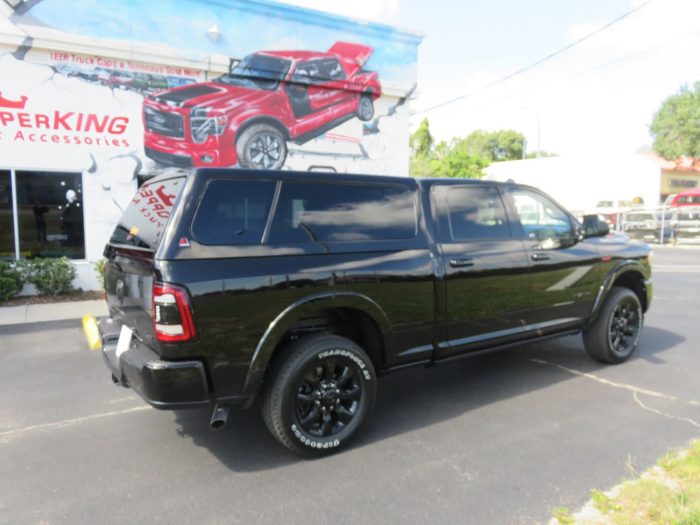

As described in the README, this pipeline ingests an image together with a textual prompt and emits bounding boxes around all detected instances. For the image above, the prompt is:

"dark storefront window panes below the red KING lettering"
[0,171,85,259]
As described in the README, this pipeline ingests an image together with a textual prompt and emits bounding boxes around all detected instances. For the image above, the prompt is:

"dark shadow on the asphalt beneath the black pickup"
[175,326,685,472]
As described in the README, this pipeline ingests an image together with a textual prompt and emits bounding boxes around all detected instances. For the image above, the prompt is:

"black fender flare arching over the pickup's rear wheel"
[243,292,391,397]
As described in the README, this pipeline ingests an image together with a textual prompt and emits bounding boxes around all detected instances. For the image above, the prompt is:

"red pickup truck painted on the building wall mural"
[143,42,381,169]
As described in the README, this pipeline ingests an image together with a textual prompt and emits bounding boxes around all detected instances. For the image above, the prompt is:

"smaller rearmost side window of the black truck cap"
[192,179,275,245]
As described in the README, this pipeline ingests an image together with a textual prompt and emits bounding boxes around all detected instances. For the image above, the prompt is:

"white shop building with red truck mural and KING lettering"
[0,0,421,289]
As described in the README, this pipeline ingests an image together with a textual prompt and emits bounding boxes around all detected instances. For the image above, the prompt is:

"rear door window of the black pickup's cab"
[447,187,510,241]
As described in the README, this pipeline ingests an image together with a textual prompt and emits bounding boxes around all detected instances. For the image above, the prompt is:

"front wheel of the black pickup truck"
[583,286,644,364]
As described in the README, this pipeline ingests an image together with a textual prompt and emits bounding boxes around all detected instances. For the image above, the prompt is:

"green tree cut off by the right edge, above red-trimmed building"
[651,82,700,160]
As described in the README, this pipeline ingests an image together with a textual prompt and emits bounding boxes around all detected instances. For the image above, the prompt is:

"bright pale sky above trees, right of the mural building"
[282,0,700,155]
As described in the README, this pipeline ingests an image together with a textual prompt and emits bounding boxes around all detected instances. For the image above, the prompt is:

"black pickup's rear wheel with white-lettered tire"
[262,333,377,457]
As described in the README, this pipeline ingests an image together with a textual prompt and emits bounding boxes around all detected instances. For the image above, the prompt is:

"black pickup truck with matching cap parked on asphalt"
[84,169,652,456]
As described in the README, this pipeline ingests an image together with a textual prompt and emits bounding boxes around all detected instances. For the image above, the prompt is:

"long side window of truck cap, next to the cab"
[269,182,416,243]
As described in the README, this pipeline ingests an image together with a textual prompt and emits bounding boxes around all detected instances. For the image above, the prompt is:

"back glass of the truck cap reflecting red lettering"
[109,177,185,251]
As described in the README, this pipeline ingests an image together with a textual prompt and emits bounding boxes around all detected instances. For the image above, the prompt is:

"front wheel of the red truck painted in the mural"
[236,124,287,170]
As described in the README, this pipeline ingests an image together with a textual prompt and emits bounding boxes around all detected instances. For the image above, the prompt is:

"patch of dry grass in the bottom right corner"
[553,441,700,525]
